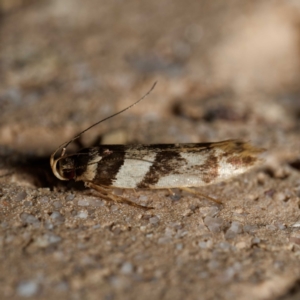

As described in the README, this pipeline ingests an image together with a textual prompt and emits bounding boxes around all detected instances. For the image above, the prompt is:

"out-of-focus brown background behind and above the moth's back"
[0,0,300,155]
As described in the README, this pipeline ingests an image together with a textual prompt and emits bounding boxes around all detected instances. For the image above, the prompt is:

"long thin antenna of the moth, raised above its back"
[50,81,157,180]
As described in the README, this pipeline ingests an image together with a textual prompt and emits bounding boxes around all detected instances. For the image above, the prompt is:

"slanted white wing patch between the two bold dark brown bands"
[113,152,156,188]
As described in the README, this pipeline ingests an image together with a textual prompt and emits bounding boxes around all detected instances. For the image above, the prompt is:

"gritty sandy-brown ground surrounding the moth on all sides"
[0,0,300,300]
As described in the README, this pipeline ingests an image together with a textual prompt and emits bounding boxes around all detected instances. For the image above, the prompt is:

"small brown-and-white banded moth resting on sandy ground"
[50,83,264,208]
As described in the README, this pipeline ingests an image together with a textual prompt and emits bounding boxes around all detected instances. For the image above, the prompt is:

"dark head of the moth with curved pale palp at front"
[50,148,76,180]
